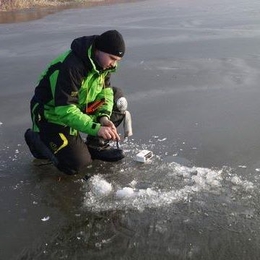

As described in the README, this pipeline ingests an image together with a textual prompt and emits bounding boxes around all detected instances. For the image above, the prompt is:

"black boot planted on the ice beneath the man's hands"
[86,136,125,162]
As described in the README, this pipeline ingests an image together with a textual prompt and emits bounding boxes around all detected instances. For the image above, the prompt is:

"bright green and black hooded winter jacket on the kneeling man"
[31,35,116,135]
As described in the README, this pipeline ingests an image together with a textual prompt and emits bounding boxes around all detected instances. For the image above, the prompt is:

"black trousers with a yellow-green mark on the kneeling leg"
[32,88,125,174]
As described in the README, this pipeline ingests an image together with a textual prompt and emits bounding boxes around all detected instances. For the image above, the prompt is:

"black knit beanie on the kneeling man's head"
[95,30,125,57]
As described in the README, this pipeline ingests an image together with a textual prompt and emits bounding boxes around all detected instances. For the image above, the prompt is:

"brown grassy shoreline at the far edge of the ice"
[0,0,144,24]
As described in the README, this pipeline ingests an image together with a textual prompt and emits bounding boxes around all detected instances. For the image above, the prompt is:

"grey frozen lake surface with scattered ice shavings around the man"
[0,0,260,260]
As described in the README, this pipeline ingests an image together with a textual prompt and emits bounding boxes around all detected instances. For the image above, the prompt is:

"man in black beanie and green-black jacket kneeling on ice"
[25,30,131,174]
